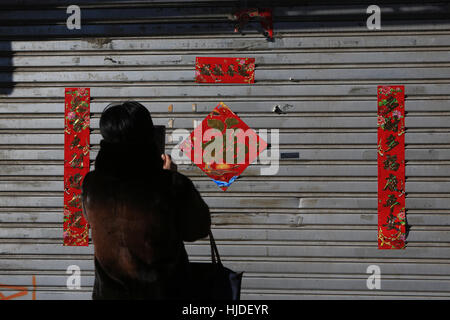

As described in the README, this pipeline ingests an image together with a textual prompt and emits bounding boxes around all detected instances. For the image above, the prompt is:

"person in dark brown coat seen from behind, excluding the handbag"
[82,101,211,299]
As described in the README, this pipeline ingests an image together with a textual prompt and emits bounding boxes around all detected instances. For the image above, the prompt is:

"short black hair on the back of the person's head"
[100,101,154,143]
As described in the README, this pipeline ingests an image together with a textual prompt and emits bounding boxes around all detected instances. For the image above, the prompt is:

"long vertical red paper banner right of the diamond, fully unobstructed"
[378,86,406,249]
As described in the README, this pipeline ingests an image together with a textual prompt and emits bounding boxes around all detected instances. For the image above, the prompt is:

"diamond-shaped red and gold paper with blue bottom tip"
[181,102,267,191]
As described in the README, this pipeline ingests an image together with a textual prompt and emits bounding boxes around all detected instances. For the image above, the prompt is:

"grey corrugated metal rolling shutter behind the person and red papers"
[0,0,450,299]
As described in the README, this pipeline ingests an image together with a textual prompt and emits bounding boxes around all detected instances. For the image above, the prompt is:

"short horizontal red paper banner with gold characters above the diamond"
[195,57,255,83]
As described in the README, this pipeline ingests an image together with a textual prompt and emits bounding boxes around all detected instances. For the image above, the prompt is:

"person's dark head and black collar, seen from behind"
[95,101,163,178]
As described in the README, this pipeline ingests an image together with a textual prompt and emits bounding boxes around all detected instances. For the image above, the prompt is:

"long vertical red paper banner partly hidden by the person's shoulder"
[63,88,90,246]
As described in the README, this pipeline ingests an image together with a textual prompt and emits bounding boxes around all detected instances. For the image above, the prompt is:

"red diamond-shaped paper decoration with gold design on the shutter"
[180,102,267,191]
